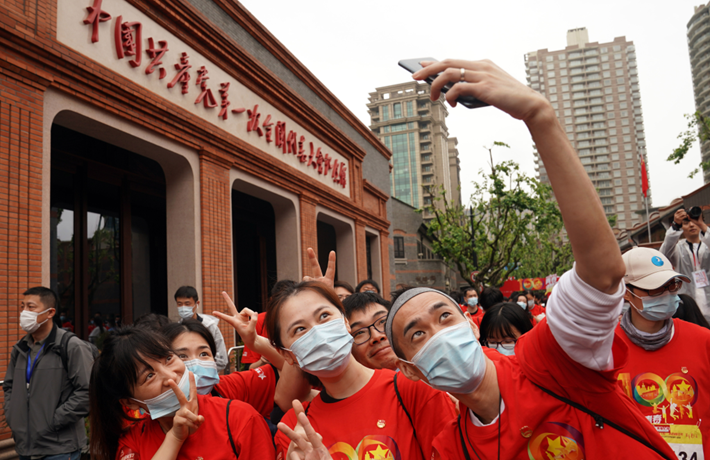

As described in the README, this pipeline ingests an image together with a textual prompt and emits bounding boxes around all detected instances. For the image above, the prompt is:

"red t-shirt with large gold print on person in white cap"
[616,319,710,459]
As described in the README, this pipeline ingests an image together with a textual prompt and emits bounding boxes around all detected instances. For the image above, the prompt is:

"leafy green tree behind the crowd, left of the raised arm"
[426,142,572,286]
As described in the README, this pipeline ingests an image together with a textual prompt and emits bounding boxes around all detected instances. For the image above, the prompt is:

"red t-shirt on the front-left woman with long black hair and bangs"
[116,395,274,460]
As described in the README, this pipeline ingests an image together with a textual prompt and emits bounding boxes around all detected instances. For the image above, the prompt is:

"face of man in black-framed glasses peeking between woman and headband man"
[343,292,397,370]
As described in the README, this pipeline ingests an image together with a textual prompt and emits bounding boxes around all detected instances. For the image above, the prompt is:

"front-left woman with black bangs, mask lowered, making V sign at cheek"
[90,327,274,460]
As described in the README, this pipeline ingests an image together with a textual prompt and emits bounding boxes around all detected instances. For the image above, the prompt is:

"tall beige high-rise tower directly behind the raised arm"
[525,28,651,229]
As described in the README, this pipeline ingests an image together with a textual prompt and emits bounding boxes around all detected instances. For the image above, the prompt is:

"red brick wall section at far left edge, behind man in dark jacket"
[0,73,42,439]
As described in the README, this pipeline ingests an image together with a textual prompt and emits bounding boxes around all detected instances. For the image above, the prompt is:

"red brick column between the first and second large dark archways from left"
[200,151,235,349]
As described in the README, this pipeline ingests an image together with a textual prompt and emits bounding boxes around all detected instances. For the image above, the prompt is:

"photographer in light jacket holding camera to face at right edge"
[660,208,710,321]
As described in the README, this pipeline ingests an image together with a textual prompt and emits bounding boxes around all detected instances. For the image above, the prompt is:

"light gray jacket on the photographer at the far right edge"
[660,227,710,318]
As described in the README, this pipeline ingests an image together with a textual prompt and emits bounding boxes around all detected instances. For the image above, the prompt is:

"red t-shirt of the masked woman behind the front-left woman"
[214,364,278,418]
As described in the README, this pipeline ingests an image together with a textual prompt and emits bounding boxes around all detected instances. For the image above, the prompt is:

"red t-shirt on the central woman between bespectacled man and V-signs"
[275,369,455,460]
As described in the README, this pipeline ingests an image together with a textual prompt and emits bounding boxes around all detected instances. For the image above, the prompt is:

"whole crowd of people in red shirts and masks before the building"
[3,61,710,460]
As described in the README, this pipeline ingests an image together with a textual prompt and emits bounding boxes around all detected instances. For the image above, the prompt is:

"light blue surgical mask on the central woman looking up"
[284,318,353,378]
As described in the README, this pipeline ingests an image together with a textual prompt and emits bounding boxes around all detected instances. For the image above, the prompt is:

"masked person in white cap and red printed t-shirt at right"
[616,248,710,460]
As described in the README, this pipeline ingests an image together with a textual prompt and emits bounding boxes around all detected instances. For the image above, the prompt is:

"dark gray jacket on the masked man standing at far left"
[2,325,94,456]
